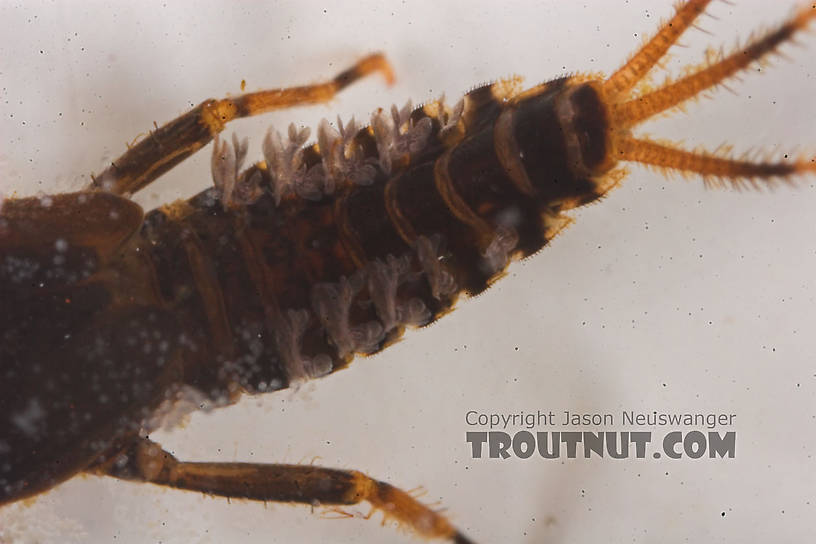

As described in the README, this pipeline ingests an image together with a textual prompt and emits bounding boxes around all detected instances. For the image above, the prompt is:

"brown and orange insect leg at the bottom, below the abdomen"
[94,439,472,544]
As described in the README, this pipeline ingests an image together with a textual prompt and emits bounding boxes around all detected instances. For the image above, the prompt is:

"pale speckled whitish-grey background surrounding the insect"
[0,0,816,543]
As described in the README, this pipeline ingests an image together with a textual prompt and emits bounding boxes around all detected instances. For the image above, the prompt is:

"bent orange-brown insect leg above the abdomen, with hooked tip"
[89,54,394,195]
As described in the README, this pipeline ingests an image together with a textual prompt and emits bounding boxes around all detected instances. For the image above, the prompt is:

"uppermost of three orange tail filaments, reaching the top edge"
[603,0,711,100]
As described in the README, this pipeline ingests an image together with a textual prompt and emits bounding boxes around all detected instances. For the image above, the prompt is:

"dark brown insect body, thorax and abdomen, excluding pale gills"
[0,80,606,502]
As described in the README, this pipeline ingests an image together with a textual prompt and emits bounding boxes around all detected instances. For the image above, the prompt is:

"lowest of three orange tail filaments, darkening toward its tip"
[615,136,816,188]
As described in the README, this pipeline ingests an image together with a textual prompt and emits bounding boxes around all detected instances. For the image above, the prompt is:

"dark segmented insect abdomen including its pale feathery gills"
[142,75,612,400]
